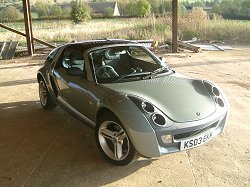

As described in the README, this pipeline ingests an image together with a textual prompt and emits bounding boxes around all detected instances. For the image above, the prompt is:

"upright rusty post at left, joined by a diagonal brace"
[23,0,34,55]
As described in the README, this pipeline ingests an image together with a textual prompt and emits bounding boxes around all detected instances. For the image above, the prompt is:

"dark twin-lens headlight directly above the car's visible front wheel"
[128,96,173,127]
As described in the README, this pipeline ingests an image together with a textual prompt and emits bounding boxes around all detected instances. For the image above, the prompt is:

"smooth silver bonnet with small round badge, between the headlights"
[105,73,216,122]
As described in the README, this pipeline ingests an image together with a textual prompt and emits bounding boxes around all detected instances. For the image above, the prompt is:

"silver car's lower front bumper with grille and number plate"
[155,113,227,156]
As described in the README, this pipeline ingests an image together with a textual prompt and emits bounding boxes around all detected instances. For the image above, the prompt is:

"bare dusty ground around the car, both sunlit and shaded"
[0,47,250,187]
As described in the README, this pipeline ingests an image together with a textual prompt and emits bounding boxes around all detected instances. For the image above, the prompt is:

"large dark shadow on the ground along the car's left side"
[0,101,154,186]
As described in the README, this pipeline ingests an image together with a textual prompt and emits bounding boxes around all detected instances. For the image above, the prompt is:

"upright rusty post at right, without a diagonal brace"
[172,0,178,53]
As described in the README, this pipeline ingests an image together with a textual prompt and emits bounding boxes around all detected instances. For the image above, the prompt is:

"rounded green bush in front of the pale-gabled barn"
[71,0,91,23]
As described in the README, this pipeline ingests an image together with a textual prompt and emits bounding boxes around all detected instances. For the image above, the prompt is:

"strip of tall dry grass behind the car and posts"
[0,9,250,44]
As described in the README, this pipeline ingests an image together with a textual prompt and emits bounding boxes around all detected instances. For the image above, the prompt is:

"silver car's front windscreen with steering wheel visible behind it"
[89,46,167,83]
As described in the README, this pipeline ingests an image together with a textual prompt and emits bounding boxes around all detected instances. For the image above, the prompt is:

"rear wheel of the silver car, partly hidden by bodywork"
[39,79,56,109]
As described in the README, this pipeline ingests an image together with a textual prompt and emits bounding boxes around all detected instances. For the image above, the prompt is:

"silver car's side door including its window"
[53,45,99,121]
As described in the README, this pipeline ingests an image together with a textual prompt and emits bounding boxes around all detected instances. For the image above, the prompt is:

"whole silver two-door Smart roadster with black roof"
[37,40,228,165]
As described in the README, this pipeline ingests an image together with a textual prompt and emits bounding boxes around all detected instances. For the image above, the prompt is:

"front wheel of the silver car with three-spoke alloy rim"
[95,113,139,166]
